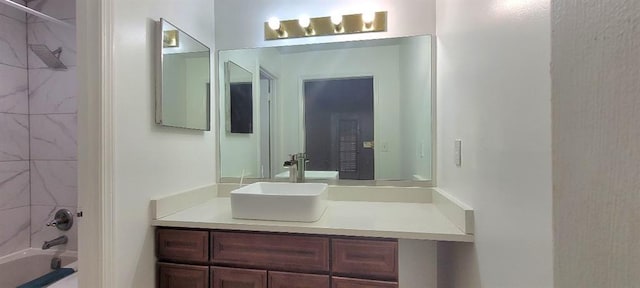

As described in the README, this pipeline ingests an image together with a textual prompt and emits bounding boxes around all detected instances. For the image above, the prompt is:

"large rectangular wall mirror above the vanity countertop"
[218,35,434,185]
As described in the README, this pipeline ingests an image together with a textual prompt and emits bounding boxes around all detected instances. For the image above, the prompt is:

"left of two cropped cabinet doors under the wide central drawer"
[211,267,267,288]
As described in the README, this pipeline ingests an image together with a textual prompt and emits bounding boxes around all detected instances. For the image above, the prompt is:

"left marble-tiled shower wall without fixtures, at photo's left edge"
[0,0,31,256]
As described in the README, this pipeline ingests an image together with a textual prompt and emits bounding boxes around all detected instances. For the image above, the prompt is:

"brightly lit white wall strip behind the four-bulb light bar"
[215,0,436,50]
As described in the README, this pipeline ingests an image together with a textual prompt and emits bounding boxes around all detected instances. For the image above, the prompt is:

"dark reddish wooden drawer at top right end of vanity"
[331,239,398,280]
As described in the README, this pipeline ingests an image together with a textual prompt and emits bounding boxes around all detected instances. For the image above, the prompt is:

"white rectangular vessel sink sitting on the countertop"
[231,182,328,222]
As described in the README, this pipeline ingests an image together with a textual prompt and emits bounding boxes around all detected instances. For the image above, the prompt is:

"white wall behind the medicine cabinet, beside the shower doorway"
[113,0,216,288]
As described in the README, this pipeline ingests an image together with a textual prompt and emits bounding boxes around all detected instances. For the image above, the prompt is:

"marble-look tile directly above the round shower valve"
[31,161,78,207]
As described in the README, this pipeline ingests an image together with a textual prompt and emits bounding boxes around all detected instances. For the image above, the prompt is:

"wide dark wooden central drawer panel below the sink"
[211,232,329,272]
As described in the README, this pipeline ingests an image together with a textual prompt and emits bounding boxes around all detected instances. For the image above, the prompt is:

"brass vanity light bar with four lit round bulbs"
[264,11,387,40]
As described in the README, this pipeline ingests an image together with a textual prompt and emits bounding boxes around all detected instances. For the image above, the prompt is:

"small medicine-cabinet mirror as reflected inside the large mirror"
[225,61,253,134]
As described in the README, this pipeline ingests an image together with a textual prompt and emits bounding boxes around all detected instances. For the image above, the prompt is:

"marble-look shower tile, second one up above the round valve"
[30,114,78,160]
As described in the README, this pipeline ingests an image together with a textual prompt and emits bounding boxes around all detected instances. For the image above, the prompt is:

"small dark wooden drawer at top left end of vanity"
[156,228,209,263]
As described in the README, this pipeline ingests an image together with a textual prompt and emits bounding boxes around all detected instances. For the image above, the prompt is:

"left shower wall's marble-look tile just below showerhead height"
[0,64,29,114]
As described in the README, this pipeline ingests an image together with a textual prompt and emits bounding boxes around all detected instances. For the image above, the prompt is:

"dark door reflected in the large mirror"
[304,77,375,180]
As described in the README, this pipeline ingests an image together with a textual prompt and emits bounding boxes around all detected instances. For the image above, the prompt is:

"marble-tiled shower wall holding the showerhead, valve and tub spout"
[27,0,78,250]
